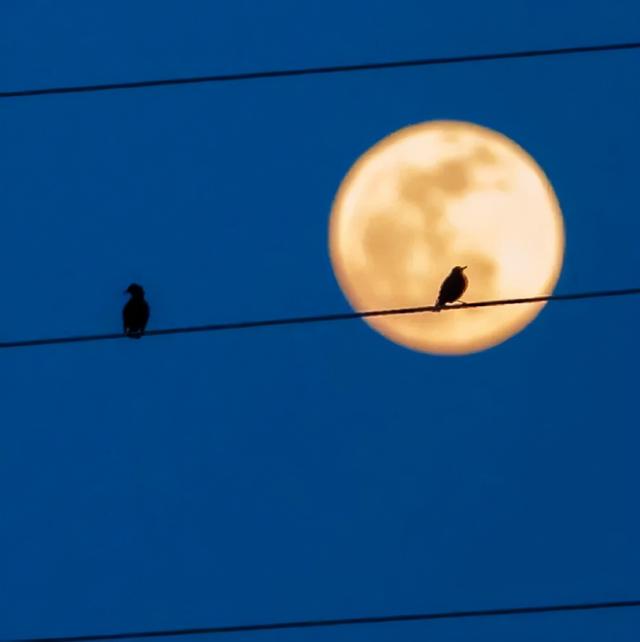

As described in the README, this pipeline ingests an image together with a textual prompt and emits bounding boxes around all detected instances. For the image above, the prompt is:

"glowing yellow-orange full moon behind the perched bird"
[329,121,564,355]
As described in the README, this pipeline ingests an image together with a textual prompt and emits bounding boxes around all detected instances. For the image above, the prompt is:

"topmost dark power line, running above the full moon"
[0,41,640,98]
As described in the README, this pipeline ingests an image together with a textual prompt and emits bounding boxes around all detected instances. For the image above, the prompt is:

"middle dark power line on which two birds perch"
[0,288,640,349]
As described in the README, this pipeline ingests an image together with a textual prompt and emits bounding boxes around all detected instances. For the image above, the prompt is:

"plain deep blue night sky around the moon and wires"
[0,0,640,642]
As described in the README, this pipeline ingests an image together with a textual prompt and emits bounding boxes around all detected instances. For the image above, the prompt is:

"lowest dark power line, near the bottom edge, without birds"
[2,600,640,642]
